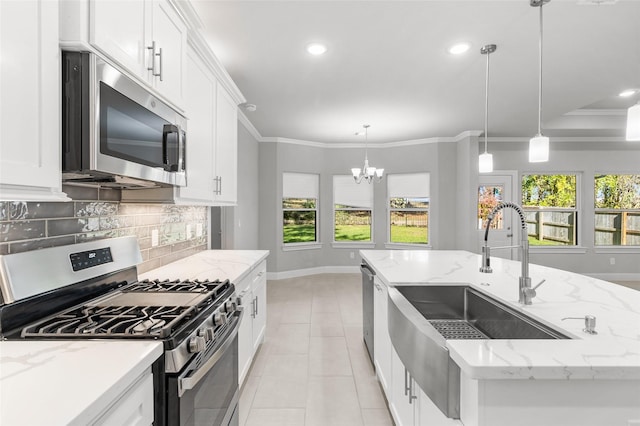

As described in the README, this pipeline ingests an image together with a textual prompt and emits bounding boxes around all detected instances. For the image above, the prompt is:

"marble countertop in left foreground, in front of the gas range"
[0,340,163,426]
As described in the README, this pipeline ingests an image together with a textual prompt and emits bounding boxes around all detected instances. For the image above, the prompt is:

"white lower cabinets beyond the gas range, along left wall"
[236,261,267,385]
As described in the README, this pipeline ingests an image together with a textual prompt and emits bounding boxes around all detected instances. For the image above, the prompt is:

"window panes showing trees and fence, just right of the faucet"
[522,174,578,246]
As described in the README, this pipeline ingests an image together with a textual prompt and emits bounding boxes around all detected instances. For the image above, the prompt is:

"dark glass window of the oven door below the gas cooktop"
[168,336,238,426]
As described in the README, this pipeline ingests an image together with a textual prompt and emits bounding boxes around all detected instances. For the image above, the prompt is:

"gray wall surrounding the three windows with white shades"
[259,139,475,272]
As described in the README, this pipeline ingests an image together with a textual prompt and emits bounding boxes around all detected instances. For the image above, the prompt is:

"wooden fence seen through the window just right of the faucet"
[523,208,577,245]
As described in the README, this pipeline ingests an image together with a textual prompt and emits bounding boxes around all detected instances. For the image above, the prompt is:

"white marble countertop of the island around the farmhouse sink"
[360,250,640,380]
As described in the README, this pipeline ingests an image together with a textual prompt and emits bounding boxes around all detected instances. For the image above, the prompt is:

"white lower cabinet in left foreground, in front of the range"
[92,369,153,426]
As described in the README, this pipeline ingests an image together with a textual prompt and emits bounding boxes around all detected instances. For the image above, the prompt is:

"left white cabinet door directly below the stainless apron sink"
[388,349,418,426]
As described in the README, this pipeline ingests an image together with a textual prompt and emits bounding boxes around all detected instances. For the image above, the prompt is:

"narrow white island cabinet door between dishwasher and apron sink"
[373,278,392,393]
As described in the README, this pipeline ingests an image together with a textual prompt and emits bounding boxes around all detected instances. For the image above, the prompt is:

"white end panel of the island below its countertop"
[460,374,640,426]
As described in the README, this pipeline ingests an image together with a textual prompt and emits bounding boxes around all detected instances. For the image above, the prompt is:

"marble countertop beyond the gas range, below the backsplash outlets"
[139,250,269,283]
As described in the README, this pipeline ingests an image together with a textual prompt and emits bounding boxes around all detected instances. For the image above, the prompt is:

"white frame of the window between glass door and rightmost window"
[514,170,586,253]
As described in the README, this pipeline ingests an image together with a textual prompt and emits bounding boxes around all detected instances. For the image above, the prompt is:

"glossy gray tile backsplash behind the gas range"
[0,185,208,273]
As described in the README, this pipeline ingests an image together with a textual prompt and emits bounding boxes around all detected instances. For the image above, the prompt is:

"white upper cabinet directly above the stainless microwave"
[60,0,187,109]
